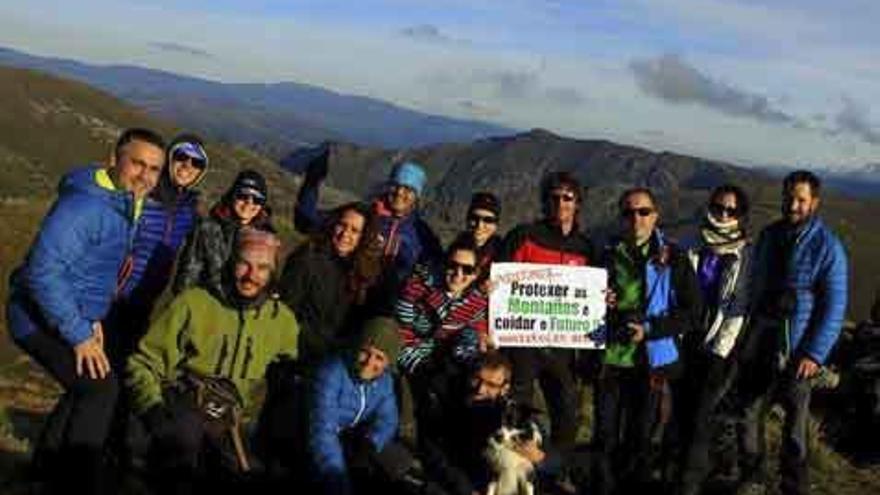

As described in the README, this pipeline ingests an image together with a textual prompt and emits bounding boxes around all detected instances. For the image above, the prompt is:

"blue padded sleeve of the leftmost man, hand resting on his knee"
[25,199,98,346]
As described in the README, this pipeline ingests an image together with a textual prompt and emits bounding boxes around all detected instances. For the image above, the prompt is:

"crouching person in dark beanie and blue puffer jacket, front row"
[307,318,406,494]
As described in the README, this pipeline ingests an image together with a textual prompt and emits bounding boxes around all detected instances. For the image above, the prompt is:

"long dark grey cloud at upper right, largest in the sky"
[630,54,805,127]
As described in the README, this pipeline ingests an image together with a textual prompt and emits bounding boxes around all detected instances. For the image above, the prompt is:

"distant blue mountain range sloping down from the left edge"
[0,48,514,156]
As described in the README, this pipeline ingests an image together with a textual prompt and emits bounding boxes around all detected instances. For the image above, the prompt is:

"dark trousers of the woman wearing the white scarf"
[677,354,736,494]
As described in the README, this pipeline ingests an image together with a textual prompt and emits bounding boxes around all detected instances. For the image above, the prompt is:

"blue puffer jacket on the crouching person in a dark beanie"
[309,356,397,484]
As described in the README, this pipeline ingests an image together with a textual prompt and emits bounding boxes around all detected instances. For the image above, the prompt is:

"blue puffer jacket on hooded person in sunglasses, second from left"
[118,191,198,308]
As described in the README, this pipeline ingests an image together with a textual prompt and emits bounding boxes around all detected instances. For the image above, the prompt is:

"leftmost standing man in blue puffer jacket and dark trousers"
[6,129,165,493]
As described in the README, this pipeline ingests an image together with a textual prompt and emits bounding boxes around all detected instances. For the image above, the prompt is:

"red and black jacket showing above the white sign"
[496,220,596,266]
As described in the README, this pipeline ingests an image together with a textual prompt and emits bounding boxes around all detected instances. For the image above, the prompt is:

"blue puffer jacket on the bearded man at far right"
[754,217,848,364]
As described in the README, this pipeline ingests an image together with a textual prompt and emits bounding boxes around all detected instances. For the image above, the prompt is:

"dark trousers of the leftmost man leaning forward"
[17,331,119,493]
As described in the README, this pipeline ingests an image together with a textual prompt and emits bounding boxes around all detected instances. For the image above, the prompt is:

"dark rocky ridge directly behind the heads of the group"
[281,129,880,320]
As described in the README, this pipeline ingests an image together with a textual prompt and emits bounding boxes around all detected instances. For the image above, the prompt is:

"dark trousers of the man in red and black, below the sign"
[506,349,578,455]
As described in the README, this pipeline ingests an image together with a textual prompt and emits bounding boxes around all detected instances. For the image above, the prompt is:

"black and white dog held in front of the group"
[483,422,542,495]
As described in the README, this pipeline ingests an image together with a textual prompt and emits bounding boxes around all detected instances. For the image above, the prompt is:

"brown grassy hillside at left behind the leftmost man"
[0,67,358,346]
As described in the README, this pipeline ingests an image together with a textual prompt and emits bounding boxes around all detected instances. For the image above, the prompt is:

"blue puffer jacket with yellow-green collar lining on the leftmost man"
[7,166,134,346]
